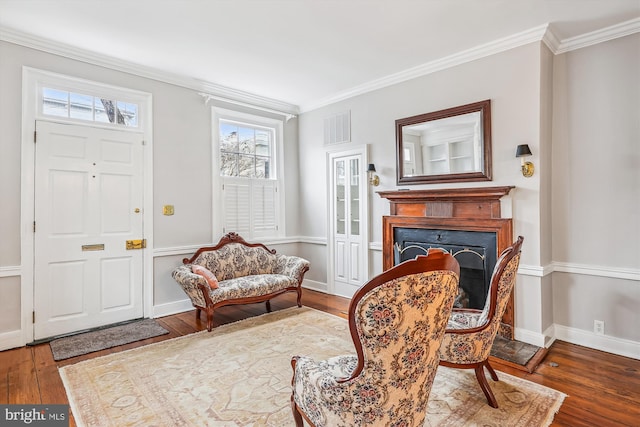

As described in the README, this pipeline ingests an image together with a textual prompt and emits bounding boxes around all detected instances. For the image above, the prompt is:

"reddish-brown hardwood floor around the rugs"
[0,290,640,427]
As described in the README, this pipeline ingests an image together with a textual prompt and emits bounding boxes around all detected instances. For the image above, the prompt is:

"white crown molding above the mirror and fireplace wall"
[300,24,549,113]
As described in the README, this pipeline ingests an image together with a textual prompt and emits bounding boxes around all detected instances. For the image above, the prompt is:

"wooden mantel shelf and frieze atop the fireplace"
[378,186,515,219]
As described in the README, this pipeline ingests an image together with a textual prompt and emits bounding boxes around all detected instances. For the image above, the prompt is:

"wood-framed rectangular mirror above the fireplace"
[396,99,491,184]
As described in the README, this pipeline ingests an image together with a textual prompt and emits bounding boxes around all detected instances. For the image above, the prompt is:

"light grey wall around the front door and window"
[0,41,298,349]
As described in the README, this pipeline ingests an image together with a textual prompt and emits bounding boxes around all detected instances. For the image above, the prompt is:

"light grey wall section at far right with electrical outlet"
[552,34,640,357]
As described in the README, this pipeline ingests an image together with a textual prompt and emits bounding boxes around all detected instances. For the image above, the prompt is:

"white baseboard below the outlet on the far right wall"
[554,325,640,360]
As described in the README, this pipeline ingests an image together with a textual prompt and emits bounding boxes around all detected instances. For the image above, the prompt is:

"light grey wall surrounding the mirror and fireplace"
[299,43,550,342]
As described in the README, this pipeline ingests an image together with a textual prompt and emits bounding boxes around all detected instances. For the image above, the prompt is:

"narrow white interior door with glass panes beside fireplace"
[330,155,367,297]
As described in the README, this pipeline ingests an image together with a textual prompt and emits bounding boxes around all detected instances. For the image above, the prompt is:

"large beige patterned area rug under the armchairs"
[60,307,565,427]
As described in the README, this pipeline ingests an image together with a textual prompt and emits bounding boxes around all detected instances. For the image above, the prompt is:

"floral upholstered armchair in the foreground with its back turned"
[291,251,460,427]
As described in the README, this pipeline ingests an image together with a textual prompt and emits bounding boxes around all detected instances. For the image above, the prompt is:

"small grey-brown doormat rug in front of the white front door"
[49,319,169,360]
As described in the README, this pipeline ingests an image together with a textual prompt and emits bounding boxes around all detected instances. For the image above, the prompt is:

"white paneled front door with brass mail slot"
[34,121,144,339]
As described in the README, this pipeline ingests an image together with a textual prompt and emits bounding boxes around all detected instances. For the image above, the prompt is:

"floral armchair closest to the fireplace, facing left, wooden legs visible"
[440,236,524,408]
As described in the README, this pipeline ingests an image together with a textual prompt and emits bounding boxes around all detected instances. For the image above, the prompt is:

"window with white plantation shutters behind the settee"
[214,109,283,240]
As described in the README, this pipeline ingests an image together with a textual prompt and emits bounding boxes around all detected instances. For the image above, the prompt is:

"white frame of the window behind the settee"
[211,106,286,241]
